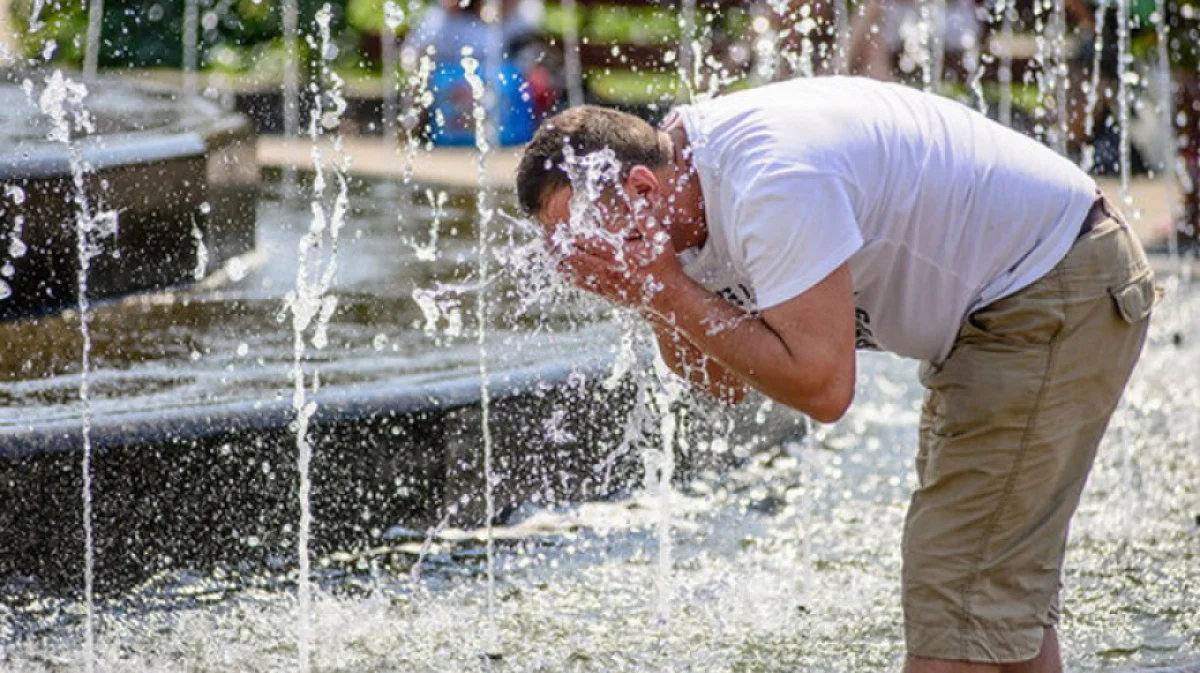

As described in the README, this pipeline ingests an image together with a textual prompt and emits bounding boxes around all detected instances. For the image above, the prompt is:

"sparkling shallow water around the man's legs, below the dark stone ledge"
[0,263,1200,673]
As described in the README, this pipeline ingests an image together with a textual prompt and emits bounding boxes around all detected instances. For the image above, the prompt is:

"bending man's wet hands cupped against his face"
[558,207,683,311]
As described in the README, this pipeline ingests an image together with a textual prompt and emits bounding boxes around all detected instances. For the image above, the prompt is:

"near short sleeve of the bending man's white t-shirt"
[732,169,863,310]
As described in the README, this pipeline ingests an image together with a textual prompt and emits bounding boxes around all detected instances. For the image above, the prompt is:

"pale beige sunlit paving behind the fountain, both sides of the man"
[255,135,1178,249]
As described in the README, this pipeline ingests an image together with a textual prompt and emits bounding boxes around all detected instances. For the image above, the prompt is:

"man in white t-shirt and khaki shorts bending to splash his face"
[517,78,1156,673]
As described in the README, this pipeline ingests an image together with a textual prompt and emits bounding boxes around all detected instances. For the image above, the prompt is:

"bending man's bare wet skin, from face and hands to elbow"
[538,127,854,422]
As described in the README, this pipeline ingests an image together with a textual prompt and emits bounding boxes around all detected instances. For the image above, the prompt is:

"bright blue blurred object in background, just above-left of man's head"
[430,61,538,145]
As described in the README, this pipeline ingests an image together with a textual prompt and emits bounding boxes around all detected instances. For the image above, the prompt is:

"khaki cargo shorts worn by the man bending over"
[902,204,1157,663]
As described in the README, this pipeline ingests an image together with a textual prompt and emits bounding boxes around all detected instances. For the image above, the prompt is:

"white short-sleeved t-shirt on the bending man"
[678,77,1096,362]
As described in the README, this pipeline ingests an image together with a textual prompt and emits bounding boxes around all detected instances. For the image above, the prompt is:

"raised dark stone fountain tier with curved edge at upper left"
[0,74,258,320]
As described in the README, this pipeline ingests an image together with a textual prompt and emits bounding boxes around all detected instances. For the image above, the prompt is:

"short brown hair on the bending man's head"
[517,106,671,216]
